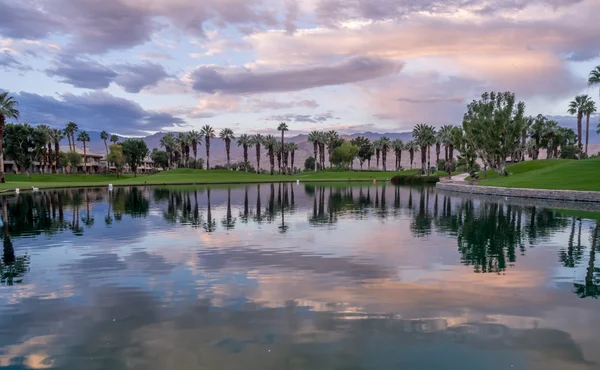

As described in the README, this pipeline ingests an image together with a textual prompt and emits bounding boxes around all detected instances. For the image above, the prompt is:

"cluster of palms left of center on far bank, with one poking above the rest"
[160,122,298,174]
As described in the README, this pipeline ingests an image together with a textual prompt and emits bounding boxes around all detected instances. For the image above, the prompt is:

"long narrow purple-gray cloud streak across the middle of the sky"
[191,57,403,94]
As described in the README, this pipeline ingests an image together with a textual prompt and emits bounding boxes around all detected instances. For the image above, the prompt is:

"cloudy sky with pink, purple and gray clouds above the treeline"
[0,0,600,135]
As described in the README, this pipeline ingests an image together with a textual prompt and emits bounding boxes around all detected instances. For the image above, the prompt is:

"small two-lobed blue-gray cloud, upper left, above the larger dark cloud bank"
[46,56,169,93]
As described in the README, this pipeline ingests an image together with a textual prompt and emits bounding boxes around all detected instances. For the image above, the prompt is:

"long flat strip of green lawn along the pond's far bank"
[0,169,446,190]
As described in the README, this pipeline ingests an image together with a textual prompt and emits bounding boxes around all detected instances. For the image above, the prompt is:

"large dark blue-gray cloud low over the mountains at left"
[10,91,185,135]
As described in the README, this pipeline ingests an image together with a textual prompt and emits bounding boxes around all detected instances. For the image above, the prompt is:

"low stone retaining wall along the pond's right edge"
[436,182,600,202]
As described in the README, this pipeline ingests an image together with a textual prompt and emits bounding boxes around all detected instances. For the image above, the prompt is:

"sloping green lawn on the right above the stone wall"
[479,158,600,191]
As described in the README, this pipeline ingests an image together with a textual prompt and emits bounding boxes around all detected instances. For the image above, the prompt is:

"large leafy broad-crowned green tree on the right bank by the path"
[463,92,525,175]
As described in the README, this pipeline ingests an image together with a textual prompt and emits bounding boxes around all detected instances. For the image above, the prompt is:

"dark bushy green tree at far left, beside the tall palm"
[3,123,45,177]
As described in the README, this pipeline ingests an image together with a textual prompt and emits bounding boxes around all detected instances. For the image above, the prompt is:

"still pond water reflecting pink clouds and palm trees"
[0,184,600,370]
